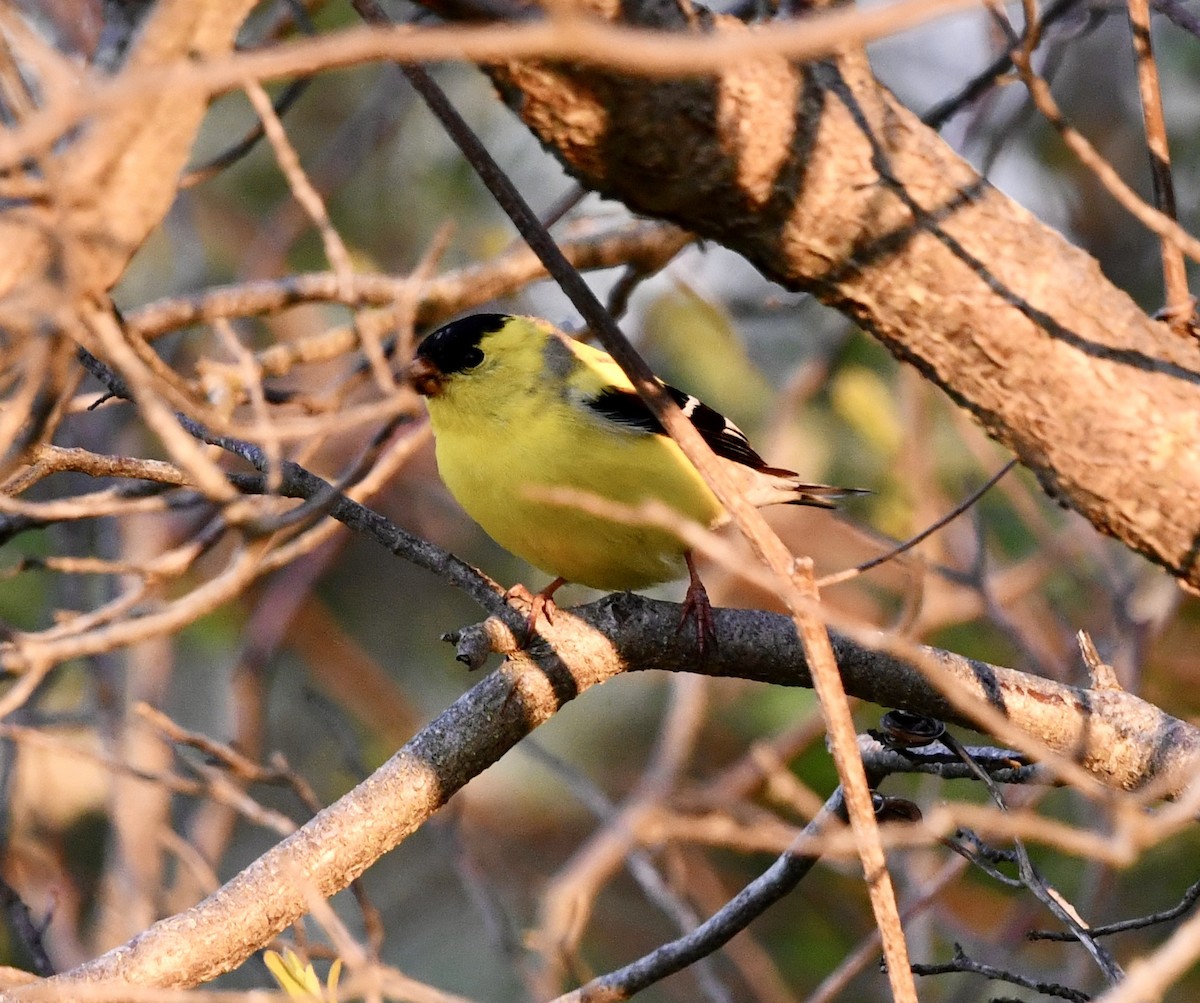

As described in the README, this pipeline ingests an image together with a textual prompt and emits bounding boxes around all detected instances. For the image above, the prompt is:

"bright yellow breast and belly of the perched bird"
[427,373,724,590]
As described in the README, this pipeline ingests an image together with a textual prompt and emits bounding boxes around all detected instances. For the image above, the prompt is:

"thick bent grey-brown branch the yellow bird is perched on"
[25,595,1200,998]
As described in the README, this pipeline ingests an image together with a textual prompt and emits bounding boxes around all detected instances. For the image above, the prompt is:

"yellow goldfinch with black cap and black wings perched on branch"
[408,313,858,644]
